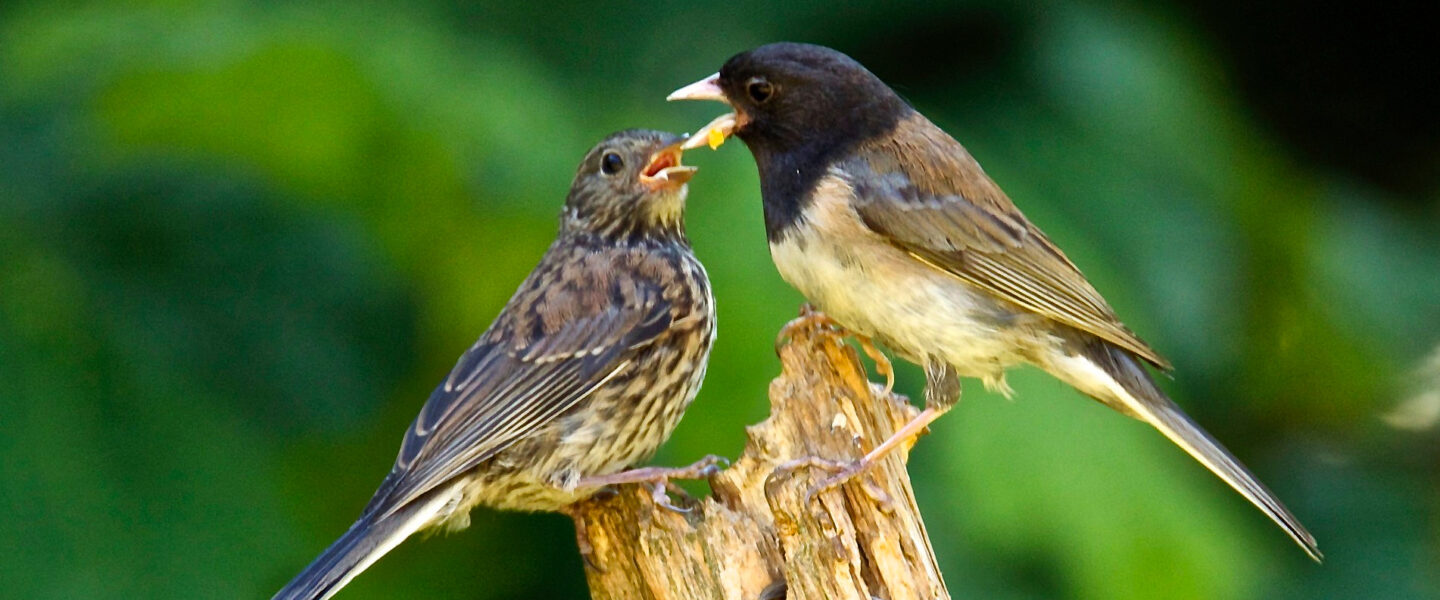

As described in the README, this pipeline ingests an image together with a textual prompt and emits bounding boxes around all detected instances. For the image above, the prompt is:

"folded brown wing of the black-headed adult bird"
[844,114,1171,370]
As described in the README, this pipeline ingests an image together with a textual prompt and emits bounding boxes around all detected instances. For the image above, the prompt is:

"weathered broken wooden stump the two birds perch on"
[576,315,949,600]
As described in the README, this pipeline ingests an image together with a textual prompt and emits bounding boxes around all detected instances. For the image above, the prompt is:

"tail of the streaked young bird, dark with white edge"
[271,494,449,600]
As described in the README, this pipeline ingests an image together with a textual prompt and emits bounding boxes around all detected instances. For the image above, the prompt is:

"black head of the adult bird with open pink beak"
[670,42,910,163]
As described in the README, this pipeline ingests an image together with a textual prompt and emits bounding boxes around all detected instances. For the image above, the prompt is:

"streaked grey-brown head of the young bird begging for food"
[560,129,696,242]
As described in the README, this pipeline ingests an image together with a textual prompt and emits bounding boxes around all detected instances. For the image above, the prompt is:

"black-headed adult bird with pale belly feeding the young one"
[670,43,1320,560]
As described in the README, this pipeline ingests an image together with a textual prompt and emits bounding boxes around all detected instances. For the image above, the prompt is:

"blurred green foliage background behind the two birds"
[0,0,1440,599]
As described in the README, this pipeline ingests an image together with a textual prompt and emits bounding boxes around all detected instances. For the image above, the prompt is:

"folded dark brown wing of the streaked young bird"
[366,253,671,514]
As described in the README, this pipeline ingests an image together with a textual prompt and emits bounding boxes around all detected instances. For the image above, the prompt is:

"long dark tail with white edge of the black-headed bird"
[1050,338,1323,563]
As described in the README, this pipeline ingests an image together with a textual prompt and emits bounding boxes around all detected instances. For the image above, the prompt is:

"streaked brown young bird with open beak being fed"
[275,129,716,599]
